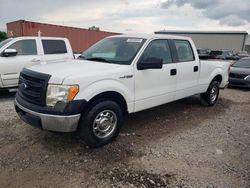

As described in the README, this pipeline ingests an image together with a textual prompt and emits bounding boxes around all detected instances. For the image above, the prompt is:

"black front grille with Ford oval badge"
[18,69,50,106]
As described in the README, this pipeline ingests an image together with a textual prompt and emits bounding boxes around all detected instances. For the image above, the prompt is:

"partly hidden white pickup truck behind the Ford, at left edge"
[0,37,74,89]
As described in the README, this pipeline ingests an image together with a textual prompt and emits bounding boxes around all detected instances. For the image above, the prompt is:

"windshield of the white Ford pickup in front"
[78,37,146,65]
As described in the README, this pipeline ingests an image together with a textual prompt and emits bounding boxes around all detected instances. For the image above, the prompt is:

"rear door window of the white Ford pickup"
[174,40,194,62]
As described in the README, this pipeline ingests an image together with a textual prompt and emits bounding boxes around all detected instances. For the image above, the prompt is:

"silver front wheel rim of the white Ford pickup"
[93,110,117,139]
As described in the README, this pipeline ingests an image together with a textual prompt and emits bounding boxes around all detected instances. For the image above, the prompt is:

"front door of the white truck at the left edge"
[0,39,40,87]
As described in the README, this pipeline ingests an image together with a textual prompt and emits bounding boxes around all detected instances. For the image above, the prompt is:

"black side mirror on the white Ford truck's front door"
[137,57,163,70]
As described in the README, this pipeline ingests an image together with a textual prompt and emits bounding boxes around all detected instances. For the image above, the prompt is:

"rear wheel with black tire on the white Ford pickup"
[201,81,220,106]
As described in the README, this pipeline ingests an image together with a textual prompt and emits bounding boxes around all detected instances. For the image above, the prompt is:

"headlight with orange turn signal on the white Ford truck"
[46,84,79,106]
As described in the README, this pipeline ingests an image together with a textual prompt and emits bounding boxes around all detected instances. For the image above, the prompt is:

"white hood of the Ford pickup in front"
[29,60,121,84]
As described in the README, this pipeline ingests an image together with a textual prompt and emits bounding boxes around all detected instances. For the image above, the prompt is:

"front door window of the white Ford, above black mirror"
[140,40,173,64]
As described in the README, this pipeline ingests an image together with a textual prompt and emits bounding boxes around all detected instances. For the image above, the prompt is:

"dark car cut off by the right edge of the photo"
[229,57,250,88]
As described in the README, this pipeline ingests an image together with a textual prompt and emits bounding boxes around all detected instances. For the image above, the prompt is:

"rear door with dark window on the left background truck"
[41,39,73,63]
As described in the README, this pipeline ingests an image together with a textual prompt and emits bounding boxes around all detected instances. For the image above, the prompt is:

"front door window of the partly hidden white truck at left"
[8,39,37,55]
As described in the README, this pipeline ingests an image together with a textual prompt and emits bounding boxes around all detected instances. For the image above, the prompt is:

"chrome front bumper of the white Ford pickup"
[14,100,80,132]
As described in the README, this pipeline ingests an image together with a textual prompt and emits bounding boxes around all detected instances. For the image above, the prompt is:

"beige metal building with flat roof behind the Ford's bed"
[155,30,248,52]
